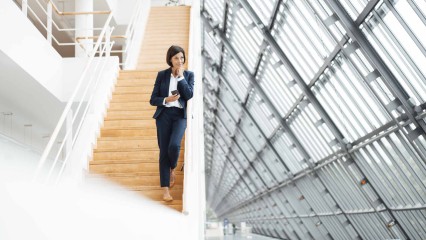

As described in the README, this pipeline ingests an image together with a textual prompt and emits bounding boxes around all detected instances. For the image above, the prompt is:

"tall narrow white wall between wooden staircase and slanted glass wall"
[183,1,206,239]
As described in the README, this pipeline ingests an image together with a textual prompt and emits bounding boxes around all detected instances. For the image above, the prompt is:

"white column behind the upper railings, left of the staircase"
[75,0,93,57]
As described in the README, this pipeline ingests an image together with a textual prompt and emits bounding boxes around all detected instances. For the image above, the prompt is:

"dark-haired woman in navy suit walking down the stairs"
[149,46,194,202]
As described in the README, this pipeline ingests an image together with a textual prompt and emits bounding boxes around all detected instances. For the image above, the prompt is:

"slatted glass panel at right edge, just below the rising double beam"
[354,132,426,207]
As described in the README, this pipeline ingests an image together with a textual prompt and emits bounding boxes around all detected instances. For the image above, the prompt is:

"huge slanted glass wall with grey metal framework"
[201,0,426,240]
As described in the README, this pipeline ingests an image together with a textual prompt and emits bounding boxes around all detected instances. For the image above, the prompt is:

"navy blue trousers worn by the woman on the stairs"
[156,107,186,187]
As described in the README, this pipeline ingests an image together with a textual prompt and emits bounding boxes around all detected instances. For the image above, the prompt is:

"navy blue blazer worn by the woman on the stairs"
[149,68,194,118]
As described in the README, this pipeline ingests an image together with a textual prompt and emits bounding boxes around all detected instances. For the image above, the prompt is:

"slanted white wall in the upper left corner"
[0,0,62,98]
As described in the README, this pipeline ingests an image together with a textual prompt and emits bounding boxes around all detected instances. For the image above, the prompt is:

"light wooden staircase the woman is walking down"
[90,6,190,211]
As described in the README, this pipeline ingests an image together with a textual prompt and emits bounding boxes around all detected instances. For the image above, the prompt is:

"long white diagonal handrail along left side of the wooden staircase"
[33,13,112,180]
